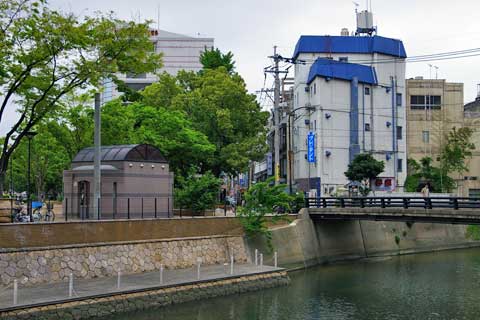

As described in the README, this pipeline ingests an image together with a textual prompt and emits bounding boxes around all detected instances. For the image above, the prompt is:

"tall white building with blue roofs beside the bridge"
[292,29,407,195]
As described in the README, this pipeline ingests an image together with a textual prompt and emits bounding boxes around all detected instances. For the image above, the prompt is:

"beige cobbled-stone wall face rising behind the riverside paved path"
[0,236,247,286]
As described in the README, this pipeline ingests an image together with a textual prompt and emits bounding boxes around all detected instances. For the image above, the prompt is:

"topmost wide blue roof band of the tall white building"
[293,36,407,59]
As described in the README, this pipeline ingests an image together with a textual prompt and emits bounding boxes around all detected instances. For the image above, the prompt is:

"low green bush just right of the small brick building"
[175,168,221,213]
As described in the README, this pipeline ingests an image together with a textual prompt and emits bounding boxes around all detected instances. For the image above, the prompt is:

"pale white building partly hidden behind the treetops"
[102,30,214,104]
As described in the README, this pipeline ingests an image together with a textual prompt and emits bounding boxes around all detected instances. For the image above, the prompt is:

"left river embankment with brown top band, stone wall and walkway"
[0,217,289,319]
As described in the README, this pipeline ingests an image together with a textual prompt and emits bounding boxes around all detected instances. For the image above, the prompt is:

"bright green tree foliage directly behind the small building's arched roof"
[102,99,215,179]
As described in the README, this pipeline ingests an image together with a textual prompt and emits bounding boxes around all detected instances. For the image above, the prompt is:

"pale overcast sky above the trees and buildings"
[0,0,480,133]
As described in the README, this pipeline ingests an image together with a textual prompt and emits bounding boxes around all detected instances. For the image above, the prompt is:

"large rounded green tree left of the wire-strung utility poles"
[165,67,269,176]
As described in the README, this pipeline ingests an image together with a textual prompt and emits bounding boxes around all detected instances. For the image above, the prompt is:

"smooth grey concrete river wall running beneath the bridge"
[247,209,480,268]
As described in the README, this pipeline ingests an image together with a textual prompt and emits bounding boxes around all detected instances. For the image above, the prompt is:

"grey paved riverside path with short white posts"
[0,264,283,311]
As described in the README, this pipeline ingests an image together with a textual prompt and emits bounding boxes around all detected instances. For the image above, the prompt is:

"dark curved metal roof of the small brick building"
[72,144,167,163]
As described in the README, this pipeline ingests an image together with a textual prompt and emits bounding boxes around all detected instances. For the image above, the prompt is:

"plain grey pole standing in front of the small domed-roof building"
[93,93,101,219]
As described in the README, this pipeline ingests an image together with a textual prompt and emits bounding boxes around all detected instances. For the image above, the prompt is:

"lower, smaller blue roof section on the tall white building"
[307,58,378,84]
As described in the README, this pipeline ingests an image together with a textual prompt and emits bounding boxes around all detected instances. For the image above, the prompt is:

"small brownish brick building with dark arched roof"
[63,144,173,219]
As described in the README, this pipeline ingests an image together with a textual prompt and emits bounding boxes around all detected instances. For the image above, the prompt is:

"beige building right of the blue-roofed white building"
[407,77,480,196]
